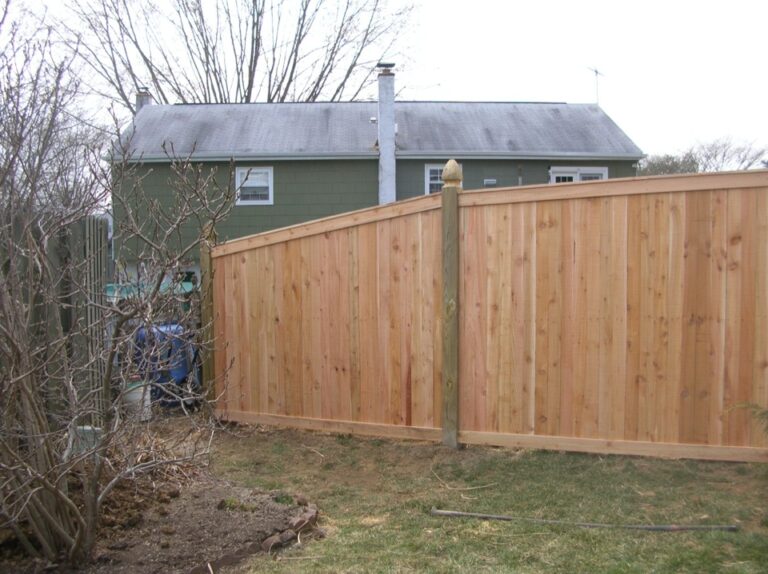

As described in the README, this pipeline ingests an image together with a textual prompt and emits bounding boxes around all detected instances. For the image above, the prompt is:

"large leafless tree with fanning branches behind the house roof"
[68,0,409,112]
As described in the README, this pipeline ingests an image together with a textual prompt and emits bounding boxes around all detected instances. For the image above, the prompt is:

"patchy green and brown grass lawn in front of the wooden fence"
[214,428,768,573]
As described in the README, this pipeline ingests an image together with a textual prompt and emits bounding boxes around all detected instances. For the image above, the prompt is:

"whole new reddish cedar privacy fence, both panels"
[206,171,768,461]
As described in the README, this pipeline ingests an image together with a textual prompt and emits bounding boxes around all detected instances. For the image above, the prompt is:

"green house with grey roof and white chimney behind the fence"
[115,65,643,276]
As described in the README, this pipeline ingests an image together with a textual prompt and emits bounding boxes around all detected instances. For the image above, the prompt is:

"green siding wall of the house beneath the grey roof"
[114,158,635,262]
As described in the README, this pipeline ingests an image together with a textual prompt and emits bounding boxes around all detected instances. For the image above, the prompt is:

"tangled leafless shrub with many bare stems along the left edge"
[0,2,233,563]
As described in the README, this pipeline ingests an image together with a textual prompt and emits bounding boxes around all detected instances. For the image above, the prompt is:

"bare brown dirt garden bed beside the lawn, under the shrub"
[0,474,313,574]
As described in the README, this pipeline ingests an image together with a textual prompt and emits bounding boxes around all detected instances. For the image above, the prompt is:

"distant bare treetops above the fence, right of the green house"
[639,138,768,175]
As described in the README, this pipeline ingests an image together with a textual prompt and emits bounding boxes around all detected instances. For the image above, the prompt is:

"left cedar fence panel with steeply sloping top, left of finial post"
[213,197,442,436]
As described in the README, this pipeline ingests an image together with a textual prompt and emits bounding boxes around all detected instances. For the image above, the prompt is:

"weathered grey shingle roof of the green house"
[126,101,643,161]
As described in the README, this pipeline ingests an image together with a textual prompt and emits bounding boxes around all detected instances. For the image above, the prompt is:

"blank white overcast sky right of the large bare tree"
[395,0,768,154]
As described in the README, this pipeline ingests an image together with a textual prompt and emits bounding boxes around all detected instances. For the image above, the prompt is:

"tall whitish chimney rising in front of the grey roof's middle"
[377,62,397,205]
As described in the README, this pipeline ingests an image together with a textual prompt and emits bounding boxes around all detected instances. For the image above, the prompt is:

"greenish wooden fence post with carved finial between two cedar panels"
[442,160,462,448]
